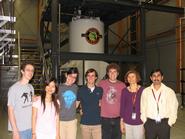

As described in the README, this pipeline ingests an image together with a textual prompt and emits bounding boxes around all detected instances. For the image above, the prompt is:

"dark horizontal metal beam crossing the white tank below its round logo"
[60,52,143,62]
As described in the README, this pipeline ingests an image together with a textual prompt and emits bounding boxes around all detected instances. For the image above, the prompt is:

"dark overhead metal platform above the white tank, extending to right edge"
[42,0,184,25]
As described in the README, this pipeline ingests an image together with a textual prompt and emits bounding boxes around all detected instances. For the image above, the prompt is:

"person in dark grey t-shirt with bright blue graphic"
[59,67,78,139]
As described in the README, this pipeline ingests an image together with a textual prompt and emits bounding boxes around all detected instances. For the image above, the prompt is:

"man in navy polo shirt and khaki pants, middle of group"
[77,68,103,139]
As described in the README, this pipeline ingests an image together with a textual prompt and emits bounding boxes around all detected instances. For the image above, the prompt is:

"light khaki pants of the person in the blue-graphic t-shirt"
[60,119,77,139]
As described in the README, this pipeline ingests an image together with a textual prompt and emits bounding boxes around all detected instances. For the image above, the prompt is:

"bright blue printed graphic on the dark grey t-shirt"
[63,90,76,109]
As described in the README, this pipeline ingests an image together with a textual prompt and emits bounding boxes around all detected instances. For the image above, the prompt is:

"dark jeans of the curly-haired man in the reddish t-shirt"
[102,117,122,139]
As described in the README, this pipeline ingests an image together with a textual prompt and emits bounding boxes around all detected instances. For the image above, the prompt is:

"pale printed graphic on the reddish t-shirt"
[106,86,117,104]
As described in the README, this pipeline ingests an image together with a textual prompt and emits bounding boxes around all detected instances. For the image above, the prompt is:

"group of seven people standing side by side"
[7,63,178,139]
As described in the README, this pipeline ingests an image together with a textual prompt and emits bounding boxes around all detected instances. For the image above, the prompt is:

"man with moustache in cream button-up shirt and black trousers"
[141,69,178,139]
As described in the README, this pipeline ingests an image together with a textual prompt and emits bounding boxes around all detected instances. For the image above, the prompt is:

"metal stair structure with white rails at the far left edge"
[0,0,18,110]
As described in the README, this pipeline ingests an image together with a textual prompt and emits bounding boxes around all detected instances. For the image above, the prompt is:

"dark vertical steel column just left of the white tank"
[51,0,59,79]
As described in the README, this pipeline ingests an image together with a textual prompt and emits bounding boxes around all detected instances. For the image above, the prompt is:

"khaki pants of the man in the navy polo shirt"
[80,124,102,139]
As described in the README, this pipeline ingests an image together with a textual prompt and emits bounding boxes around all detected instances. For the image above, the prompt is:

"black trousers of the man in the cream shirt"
[144,118,170,139]
